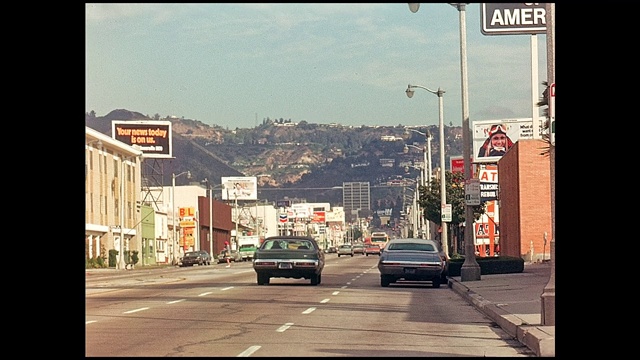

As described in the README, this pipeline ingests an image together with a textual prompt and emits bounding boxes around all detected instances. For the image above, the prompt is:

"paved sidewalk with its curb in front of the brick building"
[449,262,556,357]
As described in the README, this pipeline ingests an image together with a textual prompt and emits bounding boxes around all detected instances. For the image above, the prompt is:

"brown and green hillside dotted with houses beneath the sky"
[85,109,462,205]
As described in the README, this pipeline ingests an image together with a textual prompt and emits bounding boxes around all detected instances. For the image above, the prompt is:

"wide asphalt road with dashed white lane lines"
[85,254,534,357]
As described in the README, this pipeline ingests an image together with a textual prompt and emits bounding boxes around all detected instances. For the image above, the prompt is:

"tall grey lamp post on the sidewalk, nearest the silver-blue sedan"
[407,3,480,281]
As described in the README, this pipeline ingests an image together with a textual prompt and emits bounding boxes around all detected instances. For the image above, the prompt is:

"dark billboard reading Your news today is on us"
[111,120,173,159]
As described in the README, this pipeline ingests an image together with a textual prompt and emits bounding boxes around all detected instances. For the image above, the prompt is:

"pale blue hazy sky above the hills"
[85,3,547,129]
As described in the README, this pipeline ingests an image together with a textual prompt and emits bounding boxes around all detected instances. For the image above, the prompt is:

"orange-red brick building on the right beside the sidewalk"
[498,139,553,261]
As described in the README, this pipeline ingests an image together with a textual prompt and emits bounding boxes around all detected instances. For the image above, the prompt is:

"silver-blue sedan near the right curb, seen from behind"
[378,238,447,288]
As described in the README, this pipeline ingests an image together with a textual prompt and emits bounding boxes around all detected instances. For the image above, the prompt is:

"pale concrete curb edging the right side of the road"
[448,278,556,357]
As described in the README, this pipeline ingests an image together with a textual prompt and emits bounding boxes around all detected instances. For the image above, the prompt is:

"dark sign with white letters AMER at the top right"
[480,3,547,35]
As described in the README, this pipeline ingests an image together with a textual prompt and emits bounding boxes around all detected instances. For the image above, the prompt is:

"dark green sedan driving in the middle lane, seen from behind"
[253,236,324,285]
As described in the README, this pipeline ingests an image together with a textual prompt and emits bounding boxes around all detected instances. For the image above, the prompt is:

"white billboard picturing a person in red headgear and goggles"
[472,118,540,163]
